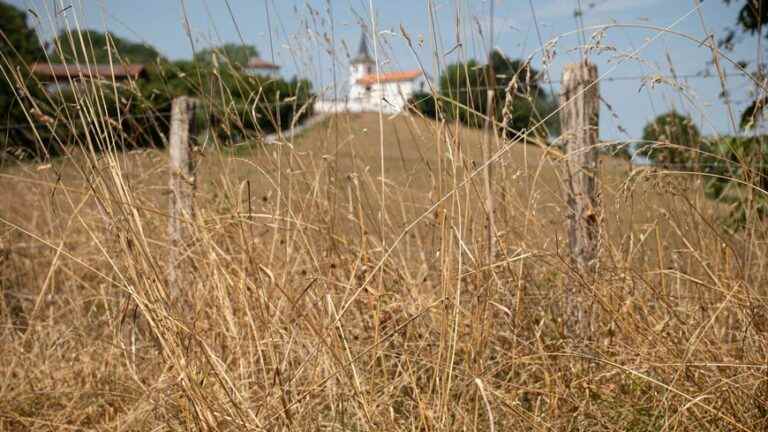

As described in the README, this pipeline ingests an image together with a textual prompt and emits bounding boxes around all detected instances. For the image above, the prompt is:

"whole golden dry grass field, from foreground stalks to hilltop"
[0,114,768,431]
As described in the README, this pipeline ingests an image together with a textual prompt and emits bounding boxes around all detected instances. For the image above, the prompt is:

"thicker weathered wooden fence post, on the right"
[560,60,600,338]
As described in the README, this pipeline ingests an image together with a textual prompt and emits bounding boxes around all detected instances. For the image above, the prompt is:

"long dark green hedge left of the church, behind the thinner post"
[5,61,312,158]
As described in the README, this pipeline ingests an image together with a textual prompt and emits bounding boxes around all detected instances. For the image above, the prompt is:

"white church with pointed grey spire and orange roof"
[315,33,424,114]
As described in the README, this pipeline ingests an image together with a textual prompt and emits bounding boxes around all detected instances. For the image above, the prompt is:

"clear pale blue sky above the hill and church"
[11,0,757,139]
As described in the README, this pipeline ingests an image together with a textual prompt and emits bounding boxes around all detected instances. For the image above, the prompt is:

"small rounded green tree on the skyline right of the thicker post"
[638,111,701,166]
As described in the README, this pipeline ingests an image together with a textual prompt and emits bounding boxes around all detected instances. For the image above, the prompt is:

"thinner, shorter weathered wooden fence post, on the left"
[168,96,196,300]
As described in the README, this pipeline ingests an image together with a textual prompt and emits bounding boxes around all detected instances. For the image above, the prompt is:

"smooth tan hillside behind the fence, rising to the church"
[0,114,717,266]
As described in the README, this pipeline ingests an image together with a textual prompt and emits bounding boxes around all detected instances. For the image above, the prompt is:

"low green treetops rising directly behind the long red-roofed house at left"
[50,30,163,64]
